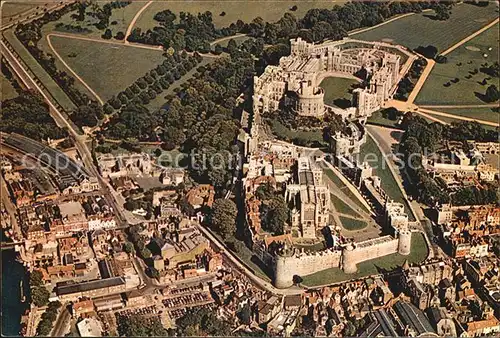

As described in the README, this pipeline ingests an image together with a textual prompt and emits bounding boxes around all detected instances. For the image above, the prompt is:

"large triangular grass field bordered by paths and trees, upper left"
[51,36,168,100]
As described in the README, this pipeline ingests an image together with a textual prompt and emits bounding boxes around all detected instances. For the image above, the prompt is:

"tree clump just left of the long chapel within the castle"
[255,183,289,235]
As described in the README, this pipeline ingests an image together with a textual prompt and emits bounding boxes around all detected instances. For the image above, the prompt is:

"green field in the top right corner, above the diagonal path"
[353,2,498,51]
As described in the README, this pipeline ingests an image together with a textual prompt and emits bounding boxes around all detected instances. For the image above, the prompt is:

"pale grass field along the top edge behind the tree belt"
[134,0,343,31]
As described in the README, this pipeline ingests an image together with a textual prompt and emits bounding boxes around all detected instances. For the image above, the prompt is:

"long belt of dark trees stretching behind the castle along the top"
[128,1,451,53]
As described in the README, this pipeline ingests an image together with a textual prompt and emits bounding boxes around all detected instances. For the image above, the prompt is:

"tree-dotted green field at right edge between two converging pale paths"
[416,24,500,105]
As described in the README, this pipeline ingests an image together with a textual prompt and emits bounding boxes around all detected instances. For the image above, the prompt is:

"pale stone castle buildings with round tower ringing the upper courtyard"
[253,38,412,119]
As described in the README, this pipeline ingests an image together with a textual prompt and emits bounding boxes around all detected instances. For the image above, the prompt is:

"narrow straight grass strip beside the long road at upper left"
[3,29,76,112]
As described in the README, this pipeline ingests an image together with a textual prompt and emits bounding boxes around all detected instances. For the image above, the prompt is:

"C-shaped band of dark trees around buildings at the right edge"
[399,113,498,206]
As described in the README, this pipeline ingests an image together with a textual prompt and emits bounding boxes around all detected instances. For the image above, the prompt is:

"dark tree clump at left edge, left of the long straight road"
[0,91,68,141]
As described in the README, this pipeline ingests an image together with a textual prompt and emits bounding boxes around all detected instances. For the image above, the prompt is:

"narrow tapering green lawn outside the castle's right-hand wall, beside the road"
[359,136,415,221]
